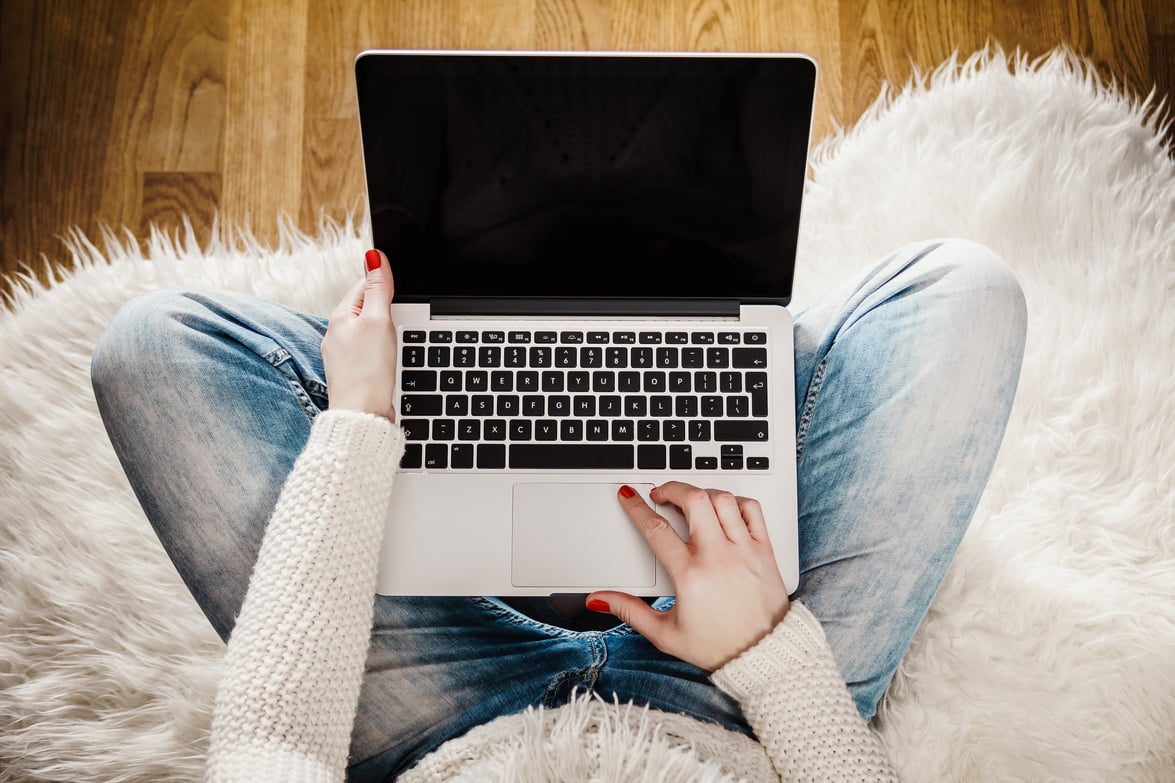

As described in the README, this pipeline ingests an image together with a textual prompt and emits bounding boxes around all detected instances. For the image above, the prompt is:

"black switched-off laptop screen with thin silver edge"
[355,52,815,303]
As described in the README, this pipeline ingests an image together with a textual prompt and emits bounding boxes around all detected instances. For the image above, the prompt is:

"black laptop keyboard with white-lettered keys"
[397,328,771,471]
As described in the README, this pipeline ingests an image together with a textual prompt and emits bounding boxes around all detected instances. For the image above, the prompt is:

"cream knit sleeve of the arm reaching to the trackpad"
[712,601,898,783]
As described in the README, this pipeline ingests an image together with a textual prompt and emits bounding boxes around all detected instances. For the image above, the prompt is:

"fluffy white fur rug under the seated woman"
[0,52,1175,781]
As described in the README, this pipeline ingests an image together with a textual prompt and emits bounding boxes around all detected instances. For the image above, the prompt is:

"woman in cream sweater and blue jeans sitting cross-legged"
[92,240,1026,781]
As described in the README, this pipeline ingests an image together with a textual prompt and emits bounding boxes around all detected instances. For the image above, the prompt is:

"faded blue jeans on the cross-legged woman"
[92,240,1026,781]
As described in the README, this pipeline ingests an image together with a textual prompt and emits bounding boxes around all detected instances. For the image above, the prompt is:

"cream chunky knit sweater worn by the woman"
[207,410,898,783]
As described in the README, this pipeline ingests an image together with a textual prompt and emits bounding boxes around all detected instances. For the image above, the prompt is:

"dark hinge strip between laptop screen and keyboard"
[429,296,739,319]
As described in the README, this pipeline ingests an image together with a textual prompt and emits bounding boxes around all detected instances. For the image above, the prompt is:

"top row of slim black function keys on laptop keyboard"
[404,329,767,346]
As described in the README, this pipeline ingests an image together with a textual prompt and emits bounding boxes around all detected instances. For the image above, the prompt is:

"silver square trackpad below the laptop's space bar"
[510,484,657,589]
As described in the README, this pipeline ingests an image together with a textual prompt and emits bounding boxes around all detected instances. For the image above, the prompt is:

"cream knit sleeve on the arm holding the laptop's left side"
[206,410,404,783]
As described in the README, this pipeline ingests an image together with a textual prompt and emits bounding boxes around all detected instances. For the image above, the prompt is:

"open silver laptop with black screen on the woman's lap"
[355,51,815,596]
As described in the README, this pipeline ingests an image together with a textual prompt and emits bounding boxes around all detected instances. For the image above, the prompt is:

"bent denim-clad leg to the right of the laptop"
[795,240,1027,720]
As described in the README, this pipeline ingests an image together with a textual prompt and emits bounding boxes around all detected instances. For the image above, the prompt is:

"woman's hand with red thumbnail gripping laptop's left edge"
[322,250,396,421]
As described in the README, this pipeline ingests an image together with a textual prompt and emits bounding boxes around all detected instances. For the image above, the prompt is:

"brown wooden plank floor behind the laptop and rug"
[0,0,1175,298]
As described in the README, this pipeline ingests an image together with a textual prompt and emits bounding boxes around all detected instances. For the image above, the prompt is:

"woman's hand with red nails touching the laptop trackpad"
[588,481,791,671]
